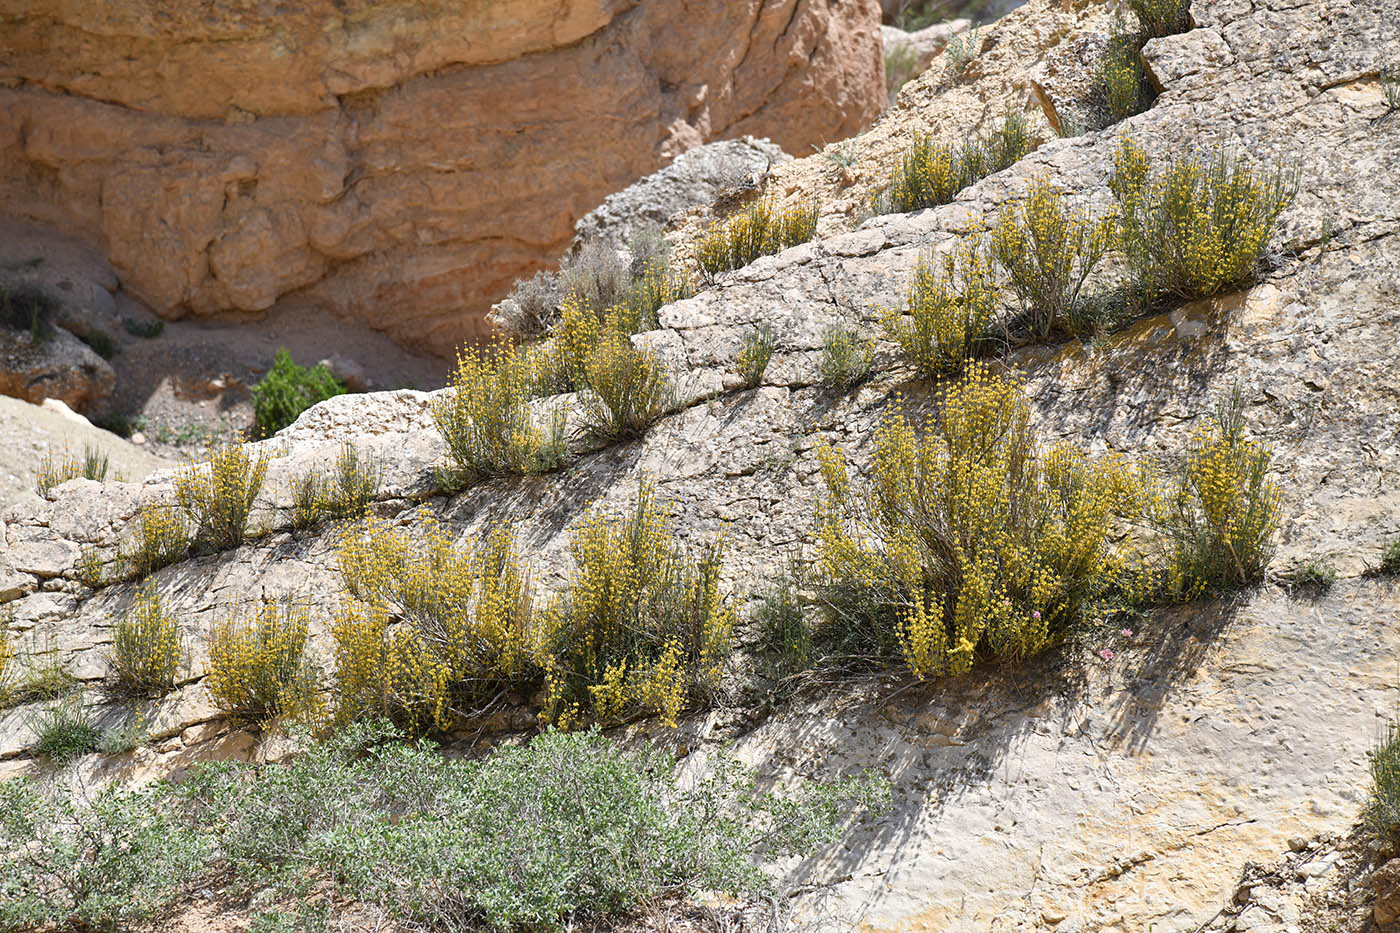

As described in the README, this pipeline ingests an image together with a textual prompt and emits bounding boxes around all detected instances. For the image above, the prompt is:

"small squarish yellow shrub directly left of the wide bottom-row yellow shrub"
[206,601,321,723]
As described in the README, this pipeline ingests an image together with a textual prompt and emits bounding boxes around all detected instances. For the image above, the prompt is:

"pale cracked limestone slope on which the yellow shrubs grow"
[0,0,1400,933]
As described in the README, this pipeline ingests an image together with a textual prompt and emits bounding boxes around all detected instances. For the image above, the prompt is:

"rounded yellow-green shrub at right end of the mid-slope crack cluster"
[580,325,675,438]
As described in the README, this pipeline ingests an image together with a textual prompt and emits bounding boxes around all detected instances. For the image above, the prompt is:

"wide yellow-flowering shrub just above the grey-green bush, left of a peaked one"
[332,520,539,728]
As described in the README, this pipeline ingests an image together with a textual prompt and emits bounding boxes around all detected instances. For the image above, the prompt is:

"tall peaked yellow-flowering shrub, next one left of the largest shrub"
[540,483,734,728]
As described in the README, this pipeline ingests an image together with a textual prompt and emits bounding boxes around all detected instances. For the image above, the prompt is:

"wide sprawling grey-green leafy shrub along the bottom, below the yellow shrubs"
[178,724,889,930]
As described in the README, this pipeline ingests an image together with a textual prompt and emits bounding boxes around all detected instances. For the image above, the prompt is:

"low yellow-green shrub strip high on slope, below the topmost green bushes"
[875,113,1036,214]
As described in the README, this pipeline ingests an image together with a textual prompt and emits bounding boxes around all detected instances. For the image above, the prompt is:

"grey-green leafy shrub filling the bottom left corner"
[0,779,206,930]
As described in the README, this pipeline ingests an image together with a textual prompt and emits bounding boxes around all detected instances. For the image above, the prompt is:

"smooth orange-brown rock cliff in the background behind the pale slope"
[0,0,883,352]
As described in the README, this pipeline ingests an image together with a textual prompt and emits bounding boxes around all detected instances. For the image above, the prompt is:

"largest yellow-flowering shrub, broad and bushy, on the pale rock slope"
[818,366,1140,677]
